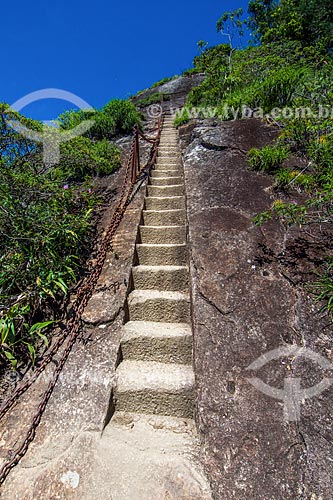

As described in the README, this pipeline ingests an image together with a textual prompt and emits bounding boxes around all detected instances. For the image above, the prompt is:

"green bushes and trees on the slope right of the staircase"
[179,0,333,312]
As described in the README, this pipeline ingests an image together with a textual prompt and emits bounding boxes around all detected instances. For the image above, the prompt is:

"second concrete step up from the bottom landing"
[121,321,192,365]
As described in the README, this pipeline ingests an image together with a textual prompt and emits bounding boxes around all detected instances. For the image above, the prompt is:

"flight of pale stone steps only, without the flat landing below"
[115,113,194,418]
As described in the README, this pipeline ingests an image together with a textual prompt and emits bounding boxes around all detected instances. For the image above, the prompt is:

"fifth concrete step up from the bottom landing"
[136,243,187,268]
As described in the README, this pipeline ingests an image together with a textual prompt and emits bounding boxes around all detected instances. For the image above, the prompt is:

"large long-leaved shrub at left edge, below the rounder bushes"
[0,155,95,367]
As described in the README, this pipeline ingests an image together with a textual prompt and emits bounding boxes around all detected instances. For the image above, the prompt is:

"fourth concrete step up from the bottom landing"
[132,265,189,292]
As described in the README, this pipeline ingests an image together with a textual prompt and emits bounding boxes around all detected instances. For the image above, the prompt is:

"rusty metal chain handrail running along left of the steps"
[0,115,162,485]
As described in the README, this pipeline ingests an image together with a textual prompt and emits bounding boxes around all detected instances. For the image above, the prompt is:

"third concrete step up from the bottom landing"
[128,290,190,323]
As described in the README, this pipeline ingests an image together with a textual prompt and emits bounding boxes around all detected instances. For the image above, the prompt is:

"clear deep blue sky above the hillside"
[0,0,248,120]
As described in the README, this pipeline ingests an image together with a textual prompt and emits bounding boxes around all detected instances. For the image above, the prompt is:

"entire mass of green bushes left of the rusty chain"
[0,100,140,369]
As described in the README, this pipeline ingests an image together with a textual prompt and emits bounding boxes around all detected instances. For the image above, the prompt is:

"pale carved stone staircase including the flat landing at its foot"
[87,117,211,500]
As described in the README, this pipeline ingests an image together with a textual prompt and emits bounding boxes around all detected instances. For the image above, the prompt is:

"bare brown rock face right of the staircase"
[180,120,333,500]
